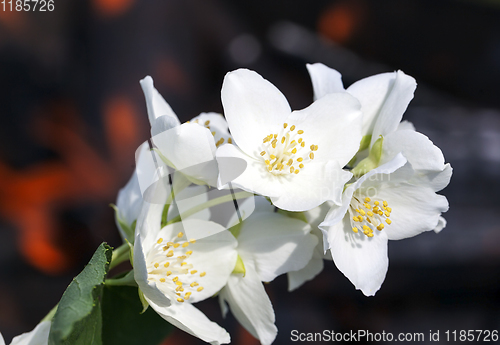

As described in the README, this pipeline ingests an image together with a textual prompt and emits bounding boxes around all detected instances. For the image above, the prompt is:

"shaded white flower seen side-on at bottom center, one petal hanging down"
[219,198,318,344]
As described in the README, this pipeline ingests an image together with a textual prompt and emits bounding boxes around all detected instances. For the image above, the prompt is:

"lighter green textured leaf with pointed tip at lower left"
[49,243,112,345]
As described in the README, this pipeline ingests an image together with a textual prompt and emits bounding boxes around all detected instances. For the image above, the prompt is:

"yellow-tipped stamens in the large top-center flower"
[260,123,318,175]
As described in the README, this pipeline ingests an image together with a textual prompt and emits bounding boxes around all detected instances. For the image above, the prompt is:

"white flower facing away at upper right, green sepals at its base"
[307,63,452,232]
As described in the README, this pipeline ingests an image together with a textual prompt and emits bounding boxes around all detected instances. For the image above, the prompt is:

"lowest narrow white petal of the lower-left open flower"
[146,297,231,345]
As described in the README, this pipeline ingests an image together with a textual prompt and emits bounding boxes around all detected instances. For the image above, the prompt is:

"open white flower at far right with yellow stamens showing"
[319,154,448,296]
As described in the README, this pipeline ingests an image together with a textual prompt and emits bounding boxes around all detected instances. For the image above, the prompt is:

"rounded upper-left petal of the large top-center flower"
[221,69,291,155]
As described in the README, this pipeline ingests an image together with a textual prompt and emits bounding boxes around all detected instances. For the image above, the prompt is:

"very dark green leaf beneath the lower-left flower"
[101,286,173,345]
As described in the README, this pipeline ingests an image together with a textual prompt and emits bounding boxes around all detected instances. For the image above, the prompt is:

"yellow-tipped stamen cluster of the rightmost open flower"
[349,196,392,237]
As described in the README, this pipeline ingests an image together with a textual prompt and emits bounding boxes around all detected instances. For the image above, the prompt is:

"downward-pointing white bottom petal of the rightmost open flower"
[329,216,389,296]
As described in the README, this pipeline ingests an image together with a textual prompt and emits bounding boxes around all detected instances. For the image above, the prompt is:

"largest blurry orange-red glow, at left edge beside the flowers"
[0,97,142,274]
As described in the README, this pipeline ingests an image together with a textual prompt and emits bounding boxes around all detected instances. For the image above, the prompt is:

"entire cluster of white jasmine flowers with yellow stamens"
[106,63,452,344]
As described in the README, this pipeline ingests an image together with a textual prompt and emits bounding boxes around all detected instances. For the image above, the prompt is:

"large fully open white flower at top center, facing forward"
[217,69,361,211]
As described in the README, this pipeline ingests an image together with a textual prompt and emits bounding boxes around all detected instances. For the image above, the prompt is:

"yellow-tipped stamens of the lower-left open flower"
[147,232,206,303]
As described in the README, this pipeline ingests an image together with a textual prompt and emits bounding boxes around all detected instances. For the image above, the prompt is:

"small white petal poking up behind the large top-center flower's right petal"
[306,63,345,100]
